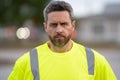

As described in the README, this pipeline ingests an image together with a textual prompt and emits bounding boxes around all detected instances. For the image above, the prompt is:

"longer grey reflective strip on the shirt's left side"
[30,49,39,80]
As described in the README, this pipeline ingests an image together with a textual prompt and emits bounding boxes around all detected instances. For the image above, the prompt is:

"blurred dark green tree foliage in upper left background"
[0,0,50,25]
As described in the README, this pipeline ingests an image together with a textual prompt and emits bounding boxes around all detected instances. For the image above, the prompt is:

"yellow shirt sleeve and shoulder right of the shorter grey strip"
[93,50,116,80]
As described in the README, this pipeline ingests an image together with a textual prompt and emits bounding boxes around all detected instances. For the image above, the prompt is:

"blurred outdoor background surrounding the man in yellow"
[0,0,120,80]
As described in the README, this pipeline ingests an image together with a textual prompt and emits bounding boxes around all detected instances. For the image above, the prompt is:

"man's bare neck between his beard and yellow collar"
[48,40,73,53]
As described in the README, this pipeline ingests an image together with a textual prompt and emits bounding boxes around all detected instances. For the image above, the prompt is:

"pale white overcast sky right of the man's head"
[53,0,120,16]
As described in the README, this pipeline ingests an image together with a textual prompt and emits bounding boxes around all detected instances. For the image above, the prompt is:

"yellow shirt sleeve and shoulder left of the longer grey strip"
[9,52,32,80]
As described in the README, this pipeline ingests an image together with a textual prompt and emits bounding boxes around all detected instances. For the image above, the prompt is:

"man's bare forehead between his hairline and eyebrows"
[48,11,71,22]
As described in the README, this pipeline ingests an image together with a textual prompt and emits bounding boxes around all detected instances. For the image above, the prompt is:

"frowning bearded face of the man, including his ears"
[44,11,75,47]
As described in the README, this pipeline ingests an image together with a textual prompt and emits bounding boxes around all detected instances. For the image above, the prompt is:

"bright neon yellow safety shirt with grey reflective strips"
[8,42,117,80]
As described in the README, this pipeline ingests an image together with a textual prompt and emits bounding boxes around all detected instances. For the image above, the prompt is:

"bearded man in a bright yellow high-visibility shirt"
[8,1,116,80]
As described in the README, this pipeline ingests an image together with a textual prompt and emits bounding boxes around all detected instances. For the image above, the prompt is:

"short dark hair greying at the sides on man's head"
[43,1,73,21]
